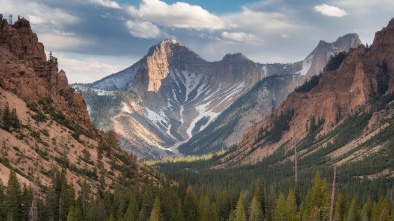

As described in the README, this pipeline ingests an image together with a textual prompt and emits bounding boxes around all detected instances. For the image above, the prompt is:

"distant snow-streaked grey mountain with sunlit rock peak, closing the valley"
[73,34,360,158]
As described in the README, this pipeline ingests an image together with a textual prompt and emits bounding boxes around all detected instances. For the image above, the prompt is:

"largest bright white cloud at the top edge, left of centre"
[128,0,225,30]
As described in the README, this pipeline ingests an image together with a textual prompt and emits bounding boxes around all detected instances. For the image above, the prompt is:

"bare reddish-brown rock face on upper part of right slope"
[217,20,394,166]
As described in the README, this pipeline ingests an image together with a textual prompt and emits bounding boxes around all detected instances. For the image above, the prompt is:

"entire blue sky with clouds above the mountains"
[0,0,394,83]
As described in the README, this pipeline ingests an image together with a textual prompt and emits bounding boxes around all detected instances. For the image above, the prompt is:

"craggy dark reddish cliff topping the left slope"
[0,18,91,127]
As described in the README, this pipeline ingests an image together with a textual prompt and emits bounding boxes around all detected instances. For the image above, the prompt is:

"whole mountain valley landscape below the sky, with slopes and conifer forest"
[0,2,394,221]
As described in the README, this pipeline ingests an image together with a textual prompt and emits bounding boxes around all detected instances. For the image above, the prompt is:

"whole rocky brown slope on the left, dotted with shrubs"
[0,18,163,195]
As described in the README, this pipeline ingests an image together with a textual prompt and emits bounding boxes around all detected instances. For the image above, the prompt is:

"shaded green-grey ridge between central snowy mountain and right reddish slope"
[179,34,361,155]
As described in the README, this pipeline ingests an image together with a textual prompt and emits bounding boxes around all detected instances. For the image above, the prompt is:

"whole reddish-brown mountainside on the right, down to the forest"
[218,19,394,171]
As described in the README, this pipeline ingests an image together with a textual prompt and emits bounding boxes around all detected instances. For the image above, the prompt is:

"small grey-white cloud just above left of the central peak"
[126,21,162,39]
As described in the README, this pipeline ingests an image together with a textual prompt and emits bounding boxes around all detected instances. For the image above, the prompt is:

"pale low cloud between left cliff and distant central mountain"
[54,54,126,83]
